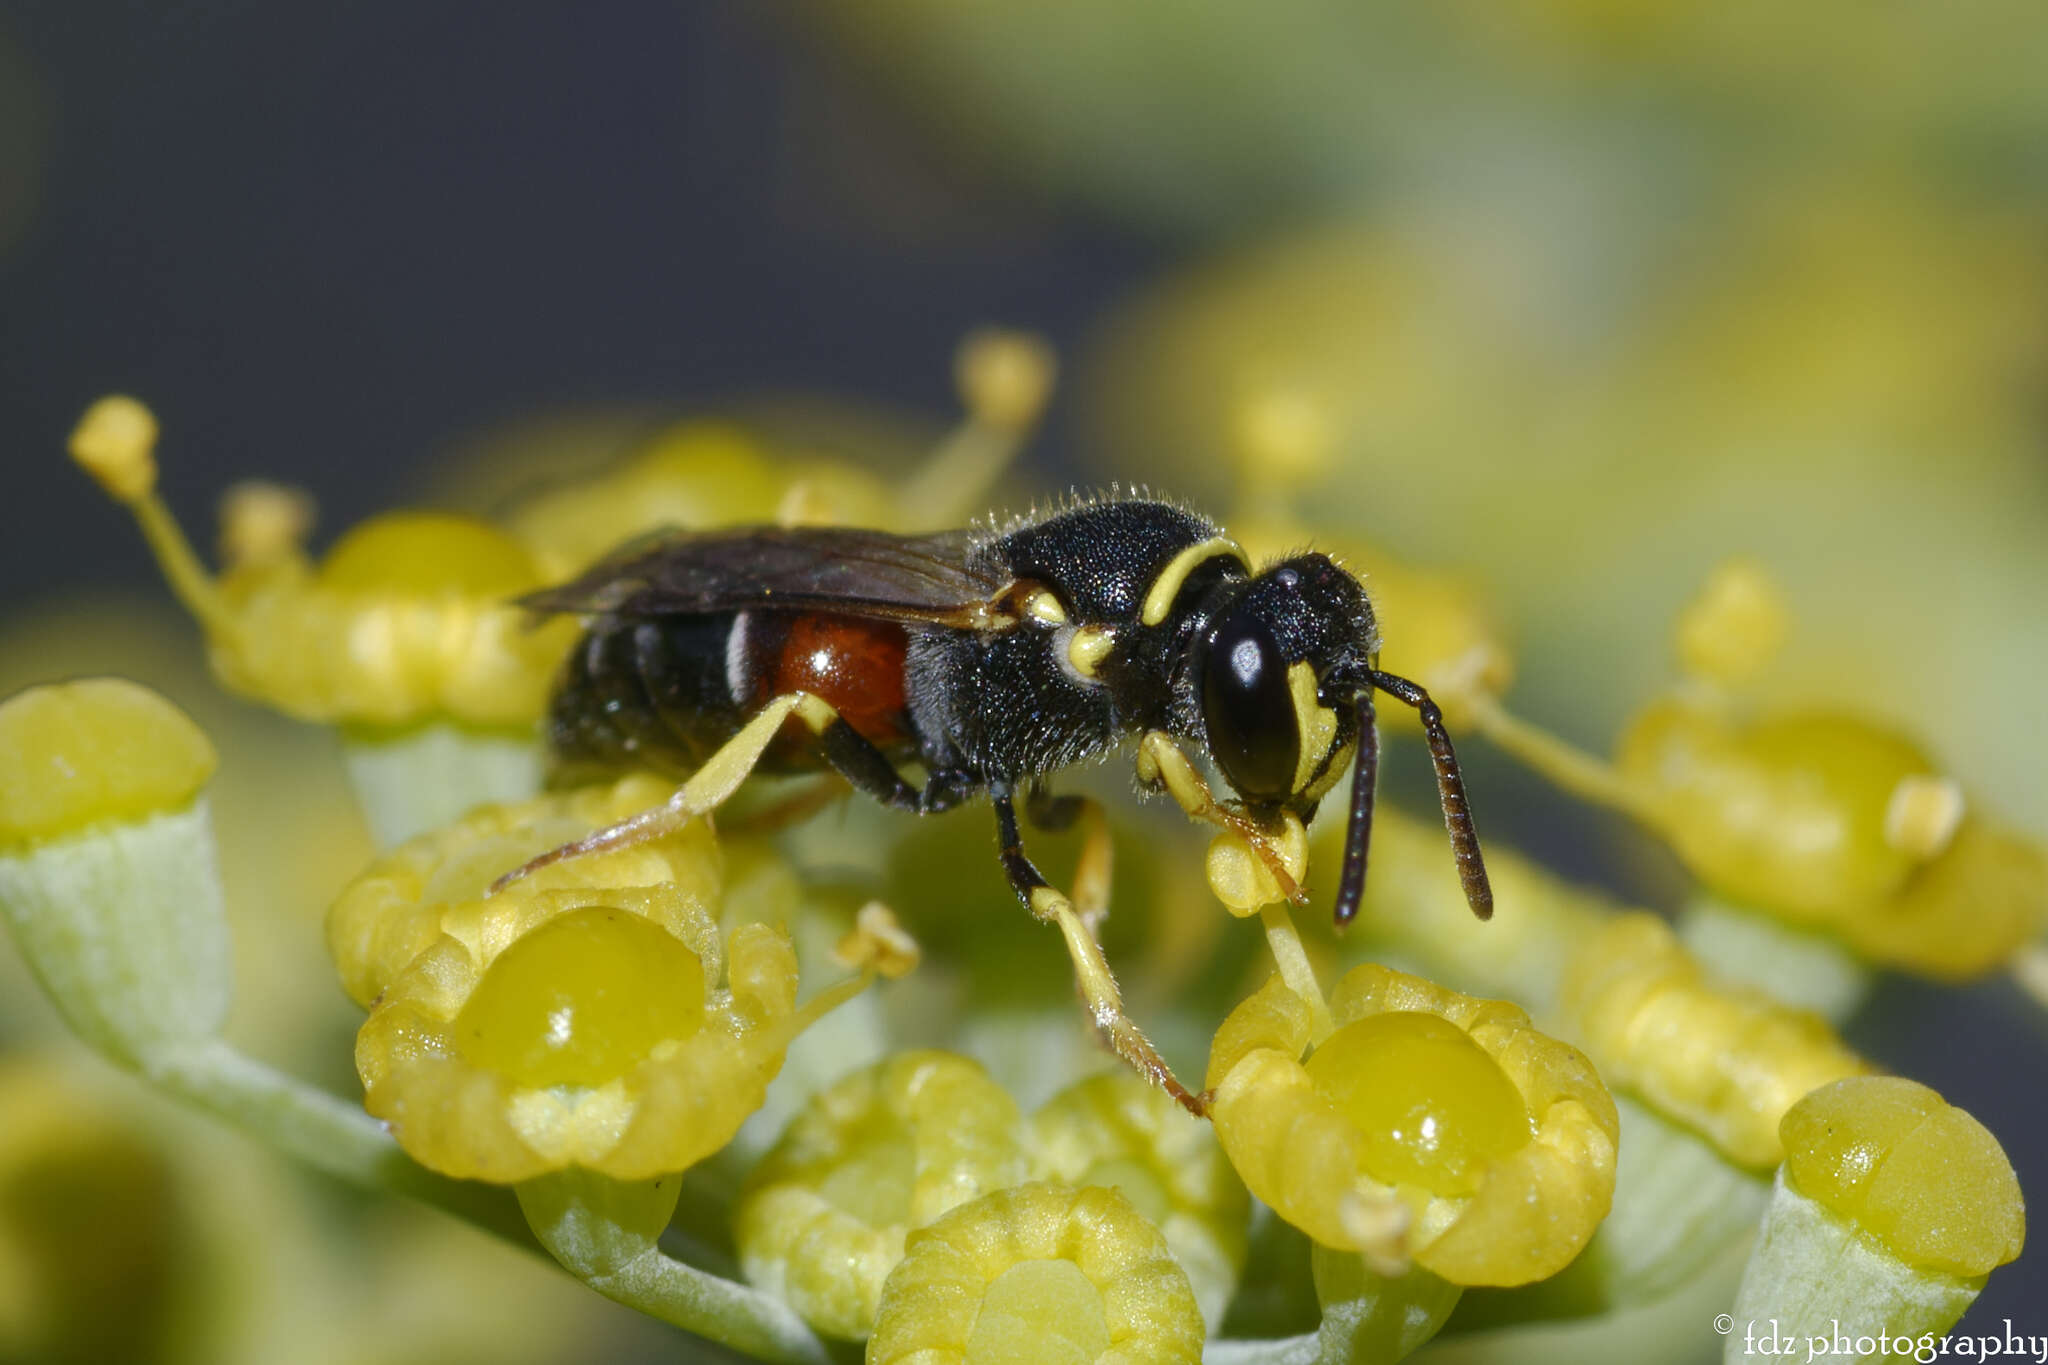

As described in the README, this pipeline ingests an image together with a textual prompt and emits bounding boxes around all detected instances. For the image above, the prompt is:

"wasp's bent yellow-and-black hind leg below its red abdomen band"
[492,692,973,892]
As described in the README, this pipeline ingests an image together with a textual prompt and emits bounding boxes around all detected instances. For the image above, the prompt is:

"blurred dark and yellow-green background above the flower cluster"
[0,0,2048,1359]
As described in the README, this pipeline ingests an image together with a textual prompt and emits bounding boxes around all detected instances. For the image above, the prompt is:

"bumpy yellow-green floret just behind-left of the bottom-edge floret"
[733,1052,1024,1340]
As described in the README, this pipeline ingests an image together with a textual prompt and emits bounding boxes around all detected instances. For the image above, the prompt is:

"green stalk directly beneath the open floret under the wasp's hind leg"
[518,1166,831,1365]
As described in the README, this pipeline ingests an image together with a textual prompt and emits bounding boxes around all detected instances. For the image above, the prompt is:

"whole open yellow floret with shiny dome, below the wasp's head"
[1208,964,1618,1285]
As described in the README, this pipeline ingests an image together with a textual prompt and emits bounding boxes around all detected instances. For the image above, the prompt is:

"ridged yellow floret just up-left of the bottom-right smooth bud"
[1563,915,1870,1166]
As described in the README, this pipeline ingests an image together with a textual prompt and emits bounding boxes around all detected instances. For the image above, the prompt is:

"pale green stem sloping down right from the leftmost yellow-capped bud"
[141,1040,532,1246]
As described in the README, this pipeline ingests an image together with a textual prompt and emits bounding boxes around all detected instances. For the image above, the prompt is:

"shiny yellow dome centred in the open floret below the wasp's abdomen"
[455,907,705,1089]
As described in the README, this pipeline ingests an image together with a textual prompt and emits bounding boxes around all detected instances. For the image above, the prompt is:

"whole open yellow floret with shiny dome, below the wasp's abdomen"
[356,886,809,1183]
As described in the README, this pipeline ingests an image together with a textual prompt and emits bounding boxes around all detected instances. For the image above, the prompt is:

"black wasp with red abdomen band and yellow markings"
[509,497,1493,1113]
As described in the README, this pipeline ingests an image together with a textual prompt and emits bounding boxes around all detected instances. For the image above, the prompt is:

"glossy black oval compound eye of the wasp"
[1202,612,1300,800]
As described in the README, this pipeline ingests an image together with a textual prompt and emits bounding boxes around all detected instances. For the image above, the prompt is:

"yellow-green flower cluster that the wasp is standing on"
[0,360,2048,1365]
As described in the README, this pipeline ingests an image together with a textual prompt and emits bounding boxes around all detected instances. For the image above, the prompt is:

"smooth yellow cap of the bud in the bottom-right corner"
[1782,1076,2025,1277]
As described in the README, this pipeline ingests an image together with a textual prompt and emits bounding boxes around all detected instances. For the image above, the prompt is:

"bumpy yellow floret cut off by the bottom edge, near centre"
[866,1185,1202,1365]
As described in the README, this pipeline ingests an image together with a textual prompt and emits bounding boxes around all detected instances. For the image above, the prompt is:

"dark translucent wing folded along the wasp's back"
[520,526,1016,630]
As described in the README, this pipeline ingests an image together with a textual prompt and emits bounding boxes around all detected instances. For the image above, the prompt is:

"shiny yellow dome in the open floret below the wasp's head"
[1307,1011,1534,1197]
